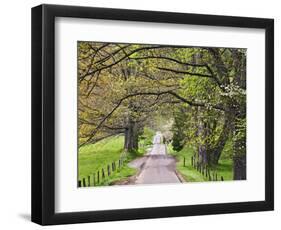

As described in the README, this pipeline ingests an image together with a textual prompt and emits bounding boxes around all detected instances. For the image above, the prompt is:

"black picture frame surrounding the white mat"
[31,5,274,225]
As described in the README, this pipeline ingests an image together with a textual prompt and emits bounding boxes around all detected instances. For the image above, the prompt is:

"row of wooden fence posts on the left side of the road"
[78,155,126,187]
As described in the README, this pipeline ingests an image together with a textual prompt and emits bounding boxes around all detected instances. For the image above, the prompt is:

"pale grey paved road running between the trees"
[129,132,180,184]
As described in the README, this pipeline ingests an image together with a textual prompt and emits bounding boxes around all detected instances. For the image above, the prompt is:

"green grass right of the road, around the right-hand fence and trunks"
[168,140,233,182]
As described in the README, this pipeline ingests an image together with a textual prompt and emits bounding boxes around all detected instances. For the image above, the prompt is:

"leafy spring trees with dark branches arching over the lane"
[78,41,246,180]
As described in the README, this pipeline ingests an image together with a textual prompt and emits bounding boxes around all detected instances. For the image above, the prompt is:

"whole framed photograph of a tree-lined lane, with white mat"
[32,5,274,225]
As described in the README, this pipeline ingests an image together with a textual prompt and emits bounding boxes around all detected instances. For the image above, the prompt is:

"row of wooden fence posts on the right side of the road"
[183,156,224,181]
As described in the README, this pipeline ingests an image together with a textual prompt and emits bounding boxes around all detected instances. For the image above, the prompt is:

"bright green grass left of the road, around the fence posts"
[78,135,147,186]
